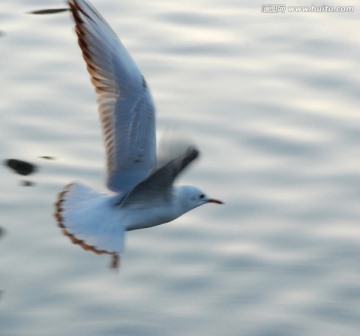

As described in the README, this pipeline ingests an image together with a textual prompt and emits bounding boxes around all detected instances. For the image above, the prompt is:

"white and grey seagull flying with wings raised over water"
[55,0,223,268]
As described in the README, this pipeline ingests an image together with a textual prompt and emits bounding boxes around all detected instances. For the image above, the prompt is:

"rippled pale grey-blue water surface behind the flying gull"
[0,0,360,336]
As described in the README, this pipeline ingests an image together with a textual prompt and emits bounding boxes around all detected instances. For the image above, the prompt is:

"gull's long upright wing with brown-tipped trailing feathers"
[68,0,156,192]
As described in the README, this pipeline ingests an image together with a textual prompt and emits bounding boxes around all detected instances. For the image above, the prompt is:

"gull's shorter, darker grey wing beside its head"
[120,147,200,206]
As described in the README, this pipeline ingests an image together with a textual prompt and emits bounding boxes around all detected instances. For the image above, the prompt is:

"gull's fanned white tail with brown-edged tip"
[55,183,125,268]
